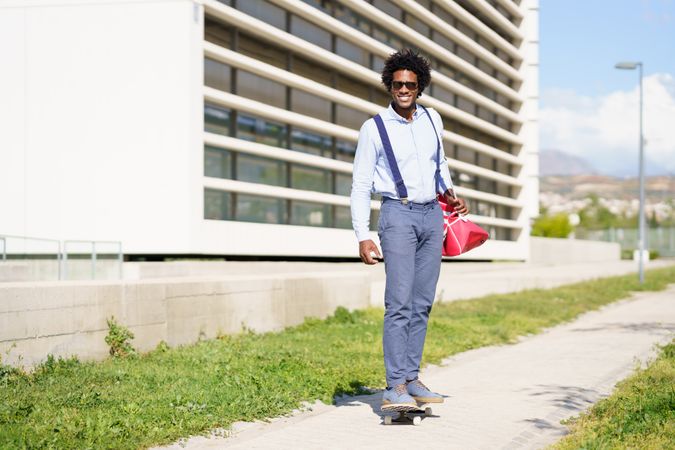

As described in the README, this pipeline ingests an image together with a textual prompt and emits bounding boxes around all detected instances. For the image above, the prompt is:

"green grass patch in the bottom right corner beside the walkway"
[554,341,675,450]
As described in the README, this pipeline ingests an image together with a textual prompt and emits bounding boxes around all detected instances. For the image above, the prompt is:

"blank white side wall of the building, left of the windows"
[0,0,203,253]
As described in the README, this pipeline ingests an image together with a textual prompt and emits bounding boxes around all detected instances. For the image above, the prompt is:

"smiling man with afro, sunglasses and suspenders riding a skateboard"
[351,49,469,411]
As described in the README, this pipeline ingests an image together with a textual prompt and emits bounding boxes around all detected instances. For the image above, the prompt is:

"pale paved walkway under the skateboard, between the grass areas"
[160,285,675,450]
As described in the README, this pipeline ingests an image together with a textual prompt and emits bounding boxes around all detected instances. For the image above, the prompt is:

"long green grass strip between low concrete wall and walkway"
[0,266,675,449]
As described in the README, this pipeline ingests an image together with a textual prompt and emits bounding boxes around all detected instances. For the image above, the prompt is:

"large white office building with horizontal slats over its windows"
[0,0,538,260]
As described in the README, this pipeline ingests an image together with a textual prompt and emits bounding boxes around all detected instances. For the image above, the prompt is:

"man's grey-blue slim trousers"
[378,198,443,387]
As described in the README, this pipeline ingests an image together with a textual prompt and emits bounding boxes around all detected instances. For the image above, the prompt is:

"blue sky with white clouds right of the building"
[539,0,675,177]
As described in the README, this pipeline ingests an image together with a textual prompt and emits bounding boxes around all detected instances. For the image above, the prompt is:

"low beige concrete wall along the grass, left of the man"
[0,272,370,366]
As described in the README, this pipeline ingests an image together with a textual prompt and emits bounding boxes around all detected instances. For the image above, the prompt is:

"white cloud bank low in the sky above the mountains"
[539,73,675,176]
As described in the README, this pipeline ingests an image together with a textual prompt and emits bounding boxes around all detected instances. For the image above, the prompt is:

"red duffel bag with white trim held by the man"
[438,195,489,256]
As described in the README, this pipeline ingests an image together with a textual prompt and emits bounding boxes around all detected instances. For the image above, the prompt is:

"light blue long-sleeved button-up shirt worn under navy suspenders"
[351,105,452,242]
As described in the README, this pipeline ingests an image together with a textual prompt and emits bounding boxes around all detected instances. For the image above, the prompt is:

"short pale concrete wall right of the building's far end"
[530,237,621,264]
